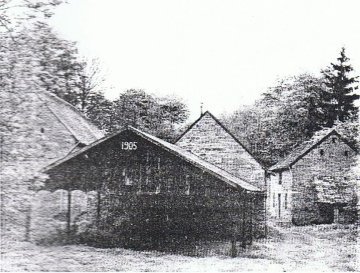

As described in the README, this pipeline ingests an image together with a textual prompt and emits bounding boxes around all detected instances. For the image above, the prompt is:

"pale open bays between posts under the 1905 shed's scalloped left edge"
[28,190,97,244]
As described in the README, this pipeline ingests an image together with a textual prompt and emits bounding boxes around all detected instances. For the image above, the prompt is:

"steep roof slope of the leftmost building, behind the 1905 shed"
[37,91,104,145]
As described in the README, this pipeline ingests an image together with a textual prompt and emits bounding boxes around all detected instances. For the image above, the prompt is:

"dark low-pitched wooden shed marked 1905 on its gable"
[45,127,265,246]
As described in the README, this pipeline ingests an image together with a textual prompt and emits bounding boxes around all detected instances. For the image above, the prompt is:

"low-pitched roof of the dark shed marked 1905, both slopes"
[43,126,261,191]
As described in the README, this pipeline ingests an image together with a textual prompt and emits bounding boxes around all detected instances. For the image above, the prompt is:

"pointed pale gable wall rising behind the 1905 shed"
[176,113,265,188]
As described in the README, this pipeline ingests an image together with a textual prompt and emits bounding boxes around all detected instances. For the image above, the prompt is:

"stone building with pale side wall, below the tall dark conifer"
[267,129,357,225]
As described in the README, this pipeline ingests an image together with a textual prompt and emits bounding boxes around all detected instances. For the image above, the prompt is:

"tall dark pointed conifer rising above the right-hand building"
[322,48,359,127]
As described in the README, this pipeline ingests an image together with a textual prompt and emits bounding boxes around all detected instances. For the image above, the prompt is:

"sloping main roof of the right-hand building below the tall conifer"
[269,128,355,171]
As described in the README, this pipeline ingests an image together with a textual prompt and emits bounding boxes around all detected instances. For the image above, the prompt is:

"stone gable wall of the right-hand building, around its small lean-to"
[291,135,355,224]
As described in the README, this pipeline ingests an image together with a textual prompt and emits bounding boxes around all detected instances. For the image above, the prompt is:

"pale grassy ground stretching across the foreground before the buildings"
[1,225,360,272]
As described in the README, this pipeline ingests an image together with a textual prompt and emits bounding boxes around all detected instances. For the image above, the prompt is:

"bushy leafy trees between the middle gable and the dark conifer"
[225,74,330,165]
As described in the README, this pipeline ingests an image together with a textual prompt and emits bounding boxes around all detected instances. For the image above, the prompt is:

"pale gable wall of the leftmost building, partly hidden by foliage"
[0,92,80,240]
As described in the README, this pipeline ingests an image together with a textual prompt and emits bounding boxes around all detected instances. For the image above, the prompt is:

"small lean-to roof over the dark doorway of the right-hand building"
[314,176,353,204]
